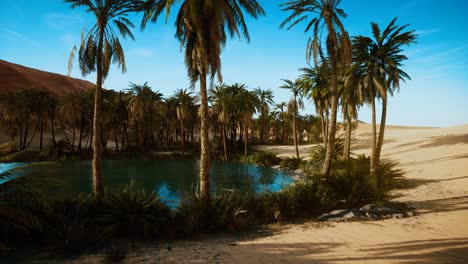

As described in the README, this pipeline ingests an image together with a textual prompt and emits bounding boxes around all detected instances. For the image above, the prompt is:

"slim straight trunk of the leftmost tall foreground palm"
[92,30,104,196]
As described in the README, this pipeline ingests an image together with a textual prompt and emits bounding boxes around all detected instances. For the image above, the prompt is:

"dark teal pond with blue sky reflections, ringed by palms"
[0,160,294,208]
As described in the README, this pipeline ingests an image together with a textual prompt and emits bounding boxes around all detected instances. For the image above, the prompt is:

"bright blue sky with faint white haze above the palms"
[0,0,468,126]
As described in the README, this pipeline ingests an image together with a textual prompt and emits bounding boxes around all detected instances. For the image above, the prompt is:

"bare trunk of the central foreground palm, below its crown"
[200,73,210,200]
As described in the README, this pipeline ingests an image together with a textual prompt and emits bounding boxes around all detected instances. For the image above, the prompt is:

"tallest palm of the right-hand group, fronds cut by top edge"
[281,0,351,177]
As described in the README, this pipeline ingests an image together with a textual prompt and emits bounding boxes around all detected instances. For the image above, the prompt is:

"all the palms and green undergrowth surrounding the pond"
[0,0,416,258]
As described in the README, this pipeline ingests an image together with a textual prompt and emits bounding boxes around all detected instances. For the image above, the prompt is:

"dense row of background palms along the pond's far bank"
[0,83,320,155]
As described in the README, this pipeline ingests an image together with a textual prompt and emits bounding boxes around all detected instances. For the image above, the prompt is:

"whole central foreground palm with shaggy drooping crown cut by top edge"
[143,0,265,199]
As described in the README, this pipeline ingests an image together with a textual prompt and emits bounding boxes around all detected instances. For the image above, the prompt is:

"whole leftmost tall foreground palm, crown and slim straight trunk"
[64,0,139,196]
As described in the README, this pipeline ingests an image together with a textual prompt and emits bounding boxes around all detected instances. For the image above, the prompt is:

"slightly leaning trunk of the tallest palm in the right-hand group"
[322,91,338,178]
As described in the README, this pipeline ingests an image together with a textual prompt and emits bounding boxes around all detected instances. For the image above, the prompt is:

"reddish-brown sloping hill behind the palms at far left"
[0,60,95,97]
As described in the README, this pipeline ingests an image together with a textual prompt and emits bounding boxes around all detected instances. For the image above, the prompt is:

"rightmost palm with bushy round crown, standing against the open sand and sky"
[353,18,417,175]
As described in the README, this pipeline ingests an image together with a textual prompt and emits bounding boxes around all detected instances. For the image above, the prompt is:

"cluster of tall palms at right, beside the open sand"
[281,0,417,180]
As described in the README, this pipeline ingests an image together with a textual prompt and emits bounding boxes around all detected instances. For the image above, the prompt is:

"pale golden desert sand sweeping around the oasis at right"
[67,124,468,264]
